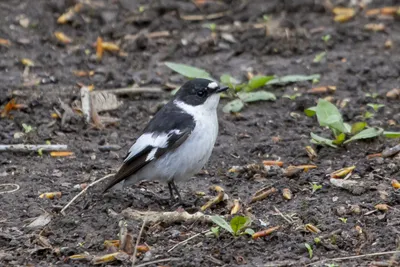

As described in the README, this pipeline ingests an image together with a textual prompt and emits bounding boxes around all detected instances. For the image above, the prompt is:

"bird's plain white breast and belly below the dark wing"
[124,108,218,185]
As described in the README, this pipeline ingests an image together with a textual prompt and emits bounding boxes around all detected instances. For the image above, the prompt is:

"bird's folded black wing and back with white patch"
[103,103,195,192]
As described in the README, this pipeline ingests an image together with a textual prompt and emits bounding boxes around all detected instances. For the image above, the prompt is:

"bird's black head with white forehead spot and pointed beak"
[175,79,228,110]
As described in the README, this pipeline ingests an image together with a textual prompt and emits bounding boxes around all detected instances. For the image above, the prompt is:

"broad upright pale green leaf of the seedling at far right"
[316,99,349,133]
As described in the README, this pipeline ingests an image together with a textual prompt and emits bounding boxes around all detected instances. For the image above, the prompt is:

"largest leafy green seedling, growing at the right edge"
[304,99,400,148]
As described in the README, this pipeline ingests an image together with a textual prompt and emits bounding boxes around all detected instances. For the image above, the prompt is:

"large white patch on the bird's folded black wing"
[124,130,181,162]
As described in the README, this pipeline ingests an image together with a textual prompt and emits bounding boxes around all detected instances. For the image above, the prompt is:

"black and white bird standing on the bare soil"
[104,79,228,201]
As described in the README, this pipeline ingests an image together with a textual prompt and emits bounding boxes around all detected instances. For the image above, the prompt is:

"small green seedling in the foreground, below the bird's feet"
[211,215,254,236]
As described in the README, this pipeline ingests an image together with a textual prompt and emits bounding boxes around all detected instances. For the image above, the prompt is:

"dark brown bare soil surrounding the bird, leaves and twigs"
[0,0,400,266]
